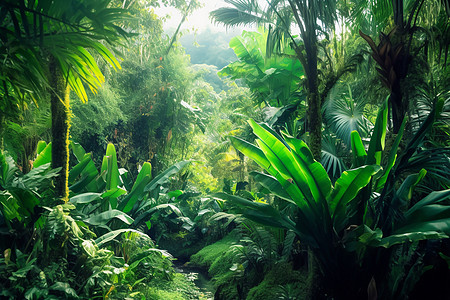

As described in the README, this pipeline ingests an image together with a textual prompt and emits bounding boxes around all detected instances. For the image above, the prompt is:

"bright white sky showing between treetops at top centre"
[155,0,253,32]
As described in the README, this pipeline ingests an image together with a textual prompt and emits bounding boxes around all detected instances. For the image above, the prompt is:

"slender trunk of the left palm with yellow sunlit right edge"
[49,56,70,202]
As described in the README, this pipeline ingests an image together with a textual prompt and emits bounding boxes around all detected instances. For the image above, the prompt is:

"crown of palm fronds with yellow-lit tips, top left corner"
[0,0,126,101]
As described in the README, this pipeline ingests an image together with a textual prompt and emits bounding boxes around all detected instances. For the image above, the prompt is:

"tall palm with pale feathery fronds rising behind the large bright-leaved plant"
[211,0,336,160]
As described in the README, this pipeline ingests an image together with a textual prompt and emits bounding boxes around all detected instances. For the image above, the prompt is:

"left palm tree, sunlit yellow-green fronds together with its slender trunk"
[0,0,126,201]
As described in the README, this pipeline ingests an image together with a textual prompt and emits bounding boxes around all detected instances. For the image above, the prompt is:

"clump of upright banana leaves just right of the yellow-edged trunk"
[69,143,190,229]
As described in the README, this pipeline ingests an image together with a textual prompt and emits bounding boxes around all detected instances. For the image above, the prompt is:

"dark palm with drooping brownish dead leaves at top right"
[354,0,449,134]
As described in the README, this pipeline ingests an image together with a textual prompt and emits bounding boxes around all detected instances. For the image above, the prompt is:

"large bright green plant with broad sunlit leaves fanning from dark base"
[215,120,380,282]
